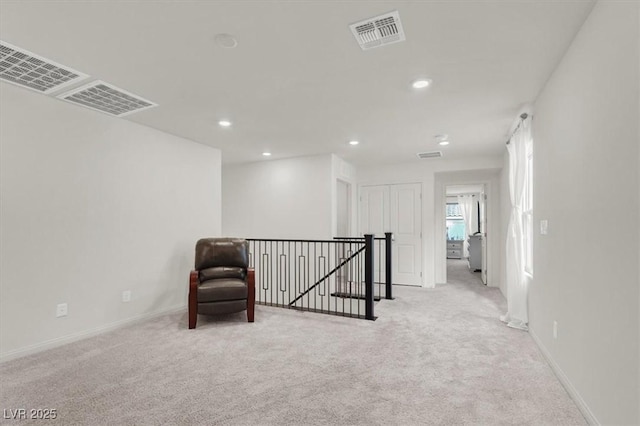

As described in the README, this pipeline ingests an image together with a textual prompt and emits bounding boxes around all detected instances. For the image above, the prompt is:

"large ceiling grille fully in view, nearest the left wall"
[58,80,158,117]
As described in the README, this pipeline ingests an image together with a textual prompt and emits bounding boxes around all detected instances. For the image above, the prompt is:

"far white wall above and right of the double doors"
[357,157,502,287]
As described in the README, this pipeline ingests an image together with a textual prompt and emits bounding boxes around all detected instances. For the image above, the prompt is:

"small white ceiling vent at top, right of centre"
[349,10,405,50]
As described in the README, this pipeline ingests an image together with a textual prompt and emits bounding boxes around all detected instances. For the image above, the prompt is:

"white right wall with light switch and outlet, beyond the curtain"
[529,1,640,424]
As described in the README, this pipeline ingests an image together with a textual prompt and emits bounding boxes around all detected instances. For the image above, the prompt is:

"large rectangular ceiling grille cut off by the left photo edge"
[0,40,88,94]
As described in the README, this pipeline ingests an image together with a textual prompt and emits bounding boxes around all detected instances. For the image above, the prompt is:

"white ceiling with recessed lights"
[0,0,593,165]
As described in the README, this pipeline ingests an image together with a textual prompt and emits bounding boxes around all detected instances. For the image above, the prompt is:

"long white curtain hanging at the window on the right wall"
[500,118,531,330]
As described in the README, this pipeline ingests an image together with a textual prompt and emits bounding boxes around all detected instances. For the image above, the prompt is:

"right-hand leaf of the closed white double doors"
[389,183,422,285]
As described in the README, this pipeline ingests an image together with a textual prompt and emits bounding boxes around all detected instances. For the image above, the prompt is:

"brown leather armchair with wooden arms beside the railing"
[189,238,255,328]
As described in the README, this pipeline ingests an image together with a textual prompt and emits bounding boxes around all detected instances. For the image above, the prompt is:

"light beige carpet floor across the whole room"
[0,261,586,425]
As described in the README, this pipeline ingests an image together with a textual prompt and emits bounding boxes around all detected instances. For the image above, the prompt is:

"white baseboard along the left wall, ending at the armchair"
[0,305,187,364]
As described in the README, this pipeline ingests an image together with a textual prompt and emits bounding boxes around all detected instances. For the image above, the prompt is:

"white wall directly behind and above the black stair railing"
[222,155,336,239]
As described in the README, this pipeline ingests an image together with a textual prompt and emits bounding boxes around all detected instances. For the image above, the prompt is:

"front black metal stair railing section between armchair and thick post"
[248,235,382,320]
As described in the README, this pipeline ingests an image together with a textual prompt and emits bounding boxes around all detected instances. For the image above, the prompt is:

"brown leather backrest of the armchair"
[195,238,249,271]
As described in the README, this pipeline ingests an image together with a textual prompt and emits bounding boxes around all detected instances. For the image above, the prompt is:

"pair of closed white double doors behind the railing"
[359,183,422,286]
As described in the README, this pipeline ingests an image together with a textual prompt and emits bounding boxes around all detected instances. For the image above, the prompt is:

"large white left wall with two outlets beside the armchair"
[0,83,220,360]
